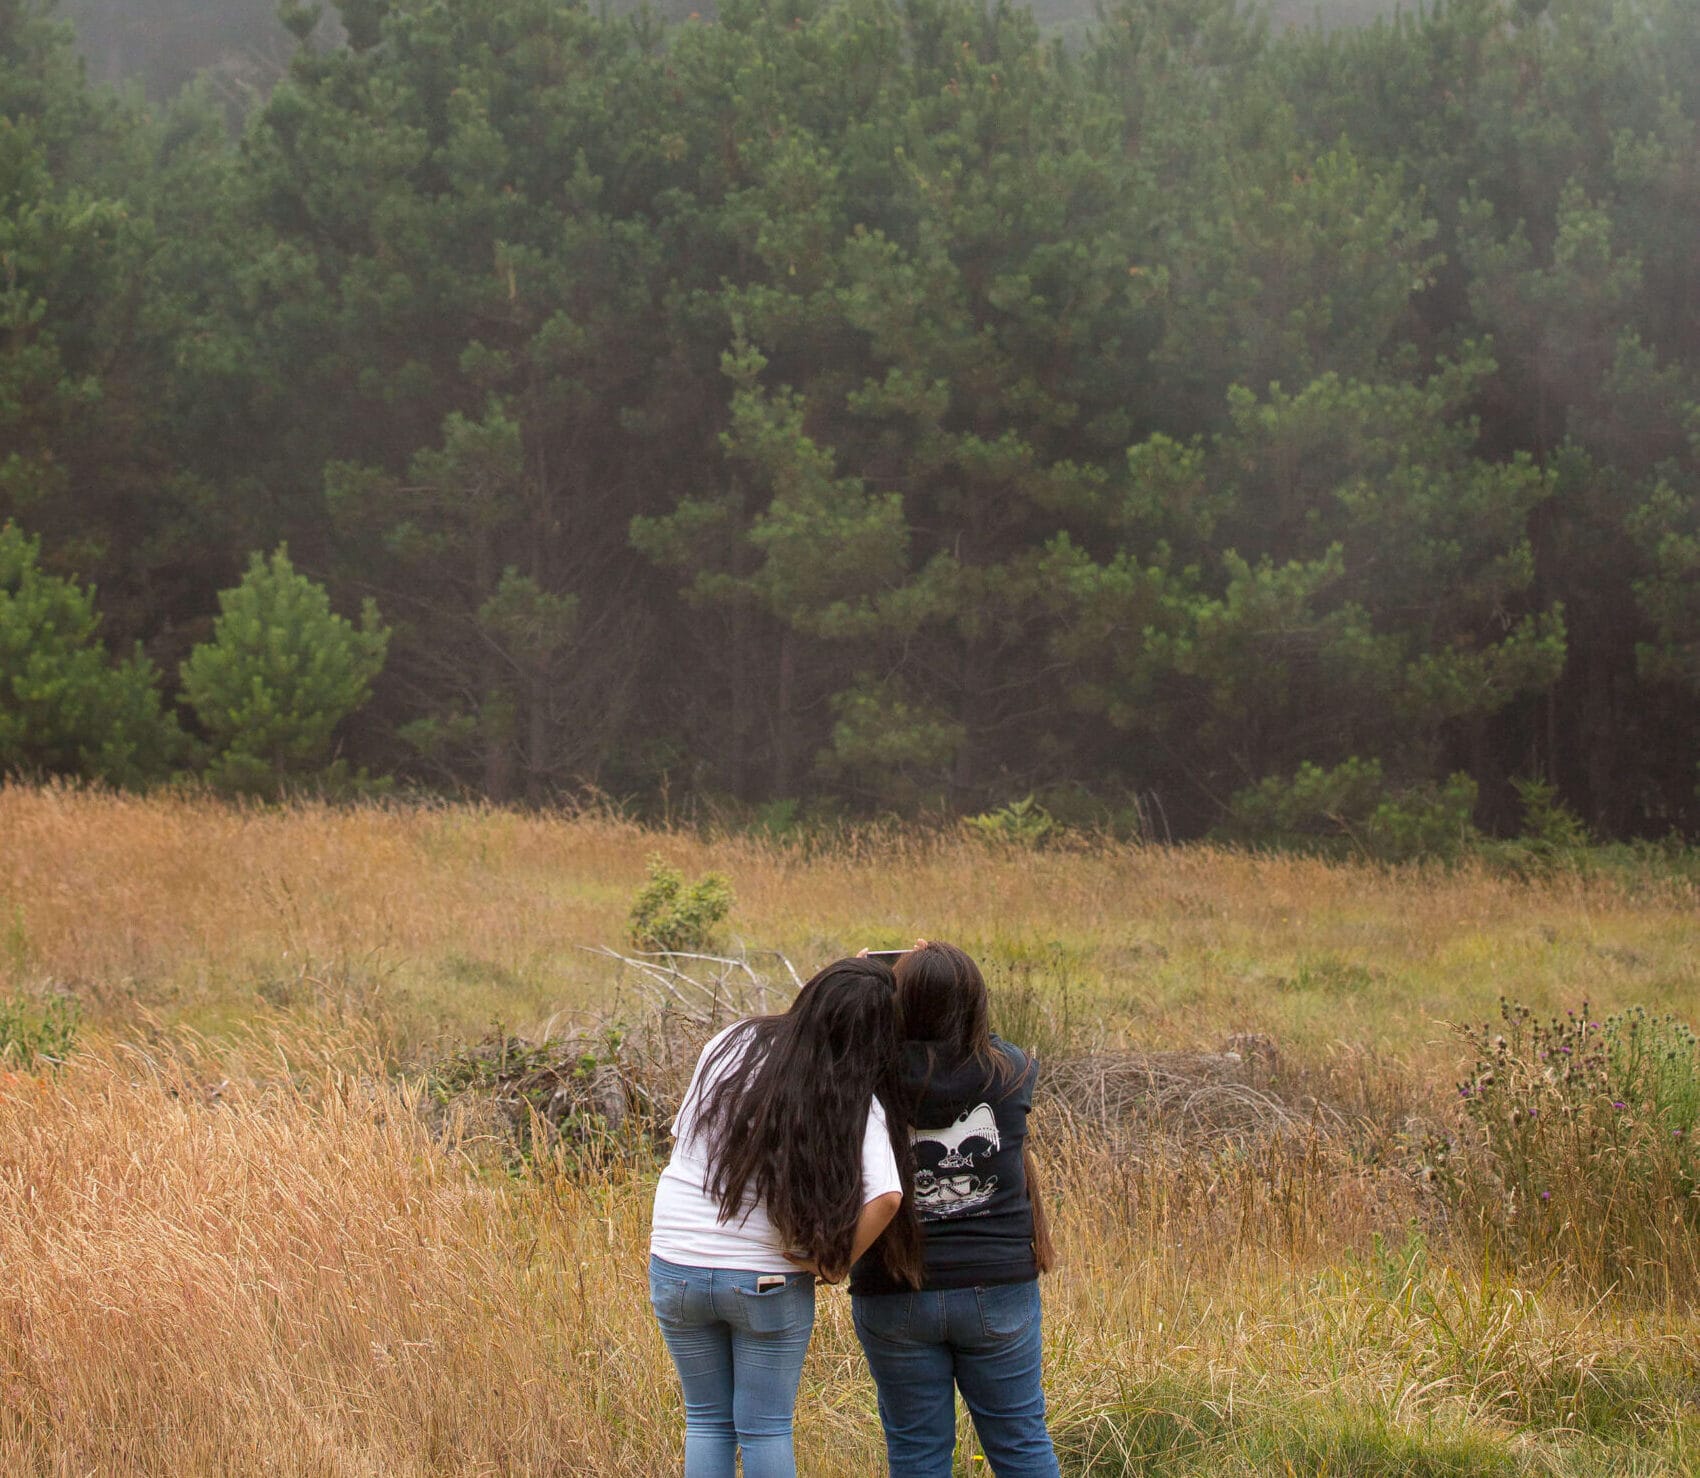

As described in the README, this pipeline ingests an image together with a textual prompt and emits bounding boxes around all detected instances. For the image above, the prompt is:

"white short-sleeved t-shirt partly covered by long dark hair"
[649,1022,903,1272]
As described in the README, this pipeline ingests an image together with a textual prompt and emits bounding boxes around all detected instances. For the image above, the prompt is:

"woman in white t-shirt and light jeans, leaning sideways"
[649,959,920,1478]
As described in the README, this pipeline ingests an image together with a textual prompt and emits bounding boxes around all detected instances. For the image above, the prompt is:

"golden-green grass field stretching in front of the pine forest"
[0,787,1700,1475]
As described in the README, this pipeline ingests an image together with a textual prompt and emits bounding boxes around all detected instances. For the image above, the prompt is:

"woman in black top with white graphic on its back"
[850,941,1057,1478]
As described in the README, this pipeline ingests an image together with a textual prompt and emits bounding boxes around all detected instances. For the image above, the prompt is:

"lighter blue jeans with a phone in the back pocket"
[649,1257,814,1478]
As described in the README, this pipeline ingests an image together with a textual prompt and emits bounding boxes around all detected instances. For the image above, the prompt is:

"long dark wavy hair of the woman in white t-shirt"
[697,959,921,1286]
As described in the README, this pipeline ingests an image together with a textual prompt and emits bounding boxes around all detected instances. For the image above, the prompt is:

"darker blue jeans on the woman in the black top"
[850,1281,1057,1478]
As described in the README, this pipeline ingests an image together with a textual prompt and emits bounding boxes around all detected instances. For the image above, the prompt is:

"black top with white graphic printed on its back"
[850,1037,1039,1293]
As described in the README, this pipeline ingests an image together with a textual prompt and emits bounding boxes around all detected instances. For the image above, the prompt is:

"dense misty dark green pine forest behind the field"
[0,0,1700,849]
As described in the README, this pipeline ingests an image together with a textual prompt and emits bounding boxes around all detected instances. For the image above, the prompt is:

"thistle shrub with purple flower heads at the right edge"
[1457,1000,1700,1288]
